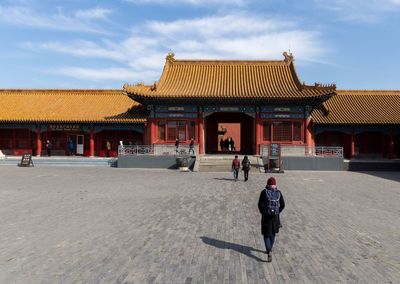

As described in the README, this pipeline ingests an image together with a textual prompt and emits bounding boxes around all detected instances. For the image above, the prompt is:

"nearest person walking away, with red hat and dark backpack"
[258,177,285,262]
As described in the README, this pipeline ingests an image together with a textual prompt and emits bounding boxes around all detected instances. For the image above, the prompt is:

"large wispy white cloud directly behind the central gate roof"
[26,14,327,83]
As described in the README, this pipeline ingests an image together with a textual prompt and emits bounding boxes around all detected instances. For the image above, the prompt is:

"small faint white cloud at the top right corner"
[313,0,400,22]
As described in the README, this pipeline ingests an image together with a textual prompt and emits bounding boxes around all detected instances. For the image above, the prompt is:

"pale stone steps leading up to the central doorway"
[194,154,264,172]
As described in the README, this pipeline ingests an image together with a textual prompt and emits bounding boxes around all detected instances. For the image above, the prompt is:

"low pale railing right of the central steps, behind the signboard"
[260,145,343,158]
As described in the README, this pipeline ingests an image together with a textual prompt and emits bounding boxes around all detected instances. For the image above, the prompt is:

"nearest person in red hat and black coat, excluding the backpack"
[258,177,285,262]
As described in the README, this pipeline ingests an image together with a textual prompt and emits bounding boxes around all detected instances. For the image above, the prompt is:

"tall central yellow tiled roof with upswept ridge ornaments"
[124,53,336,102]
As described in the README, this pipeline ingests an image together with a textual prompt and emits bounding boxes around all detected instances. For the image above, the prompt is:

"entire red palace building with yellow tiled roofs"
[0,52,400,158]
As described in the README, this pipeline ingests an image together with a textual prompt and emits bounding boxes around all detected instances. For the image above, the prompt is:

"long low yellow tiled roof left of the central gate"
[0,90,146,123]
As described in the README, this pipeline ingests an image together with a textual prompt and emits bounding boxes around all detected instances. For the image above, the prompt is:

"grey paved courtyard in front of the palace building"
[0,166,400,283]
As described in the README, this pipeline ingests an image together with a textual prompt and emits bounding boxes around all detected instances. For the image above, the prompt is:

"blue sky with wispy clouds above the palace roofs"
[0,0,400,89]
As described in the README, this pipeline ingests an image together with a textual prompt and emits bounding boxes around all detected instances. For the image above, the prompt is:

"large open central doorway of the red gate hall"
[205,112,255,154]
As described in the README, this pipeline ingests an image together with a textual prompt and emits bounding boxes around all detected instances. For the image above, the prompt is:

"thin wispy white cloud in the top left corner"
[0,5,111,34]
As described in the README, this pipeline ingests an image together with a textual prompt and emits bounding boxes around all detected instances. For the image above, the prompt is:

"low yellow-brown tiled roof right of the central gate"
[312,90,400,124]
